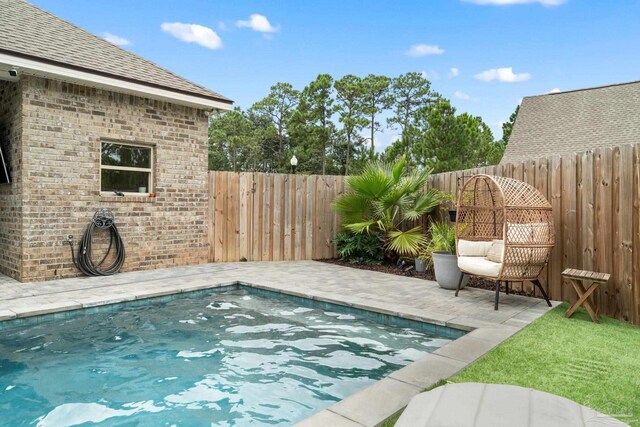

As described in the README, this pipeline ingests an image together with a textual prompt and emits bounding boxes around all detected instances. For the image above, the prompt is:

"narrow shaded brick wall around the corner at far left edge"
[0,80,22,278]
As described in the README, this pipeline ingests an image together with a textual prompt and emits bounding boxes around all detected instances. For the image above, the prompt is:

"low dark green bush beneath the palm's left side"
[334,231,384,264]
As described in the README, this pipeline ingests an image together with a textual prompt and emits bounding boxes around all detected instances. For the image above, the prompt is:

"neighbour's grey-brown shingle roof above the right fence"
[500,81,640,163]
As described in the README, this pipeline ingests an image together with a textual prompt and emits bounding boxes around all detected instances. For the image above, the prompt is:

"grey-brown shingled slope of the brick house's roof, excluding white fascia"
[0,0,232,103]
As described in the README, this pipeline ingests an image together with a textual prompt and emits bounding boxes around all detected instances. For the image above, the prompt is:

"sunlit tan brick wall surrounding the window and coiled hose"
[21,77,208,281]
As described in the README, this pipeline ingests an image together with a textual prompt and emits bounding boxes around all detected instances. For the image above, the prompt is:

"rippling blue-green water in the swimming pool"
[0,289,450,426]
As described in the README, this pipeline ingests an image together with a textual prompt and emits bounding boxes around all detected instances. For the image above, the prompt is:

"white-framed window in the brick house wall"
[100,142,153,194]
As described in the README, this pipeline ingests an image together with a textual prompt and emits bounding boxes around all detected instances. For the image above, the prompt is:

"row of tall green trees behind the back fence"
[209,72,517,175]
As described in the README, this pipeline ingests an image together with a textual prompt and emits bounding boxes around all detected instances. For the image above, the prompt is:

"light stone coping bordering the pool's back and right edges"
[0,279,546,427]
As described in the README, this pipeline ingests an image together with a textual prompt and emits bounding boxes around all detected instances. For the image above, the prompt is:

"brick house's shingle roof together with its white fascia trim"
[0,0,233,109]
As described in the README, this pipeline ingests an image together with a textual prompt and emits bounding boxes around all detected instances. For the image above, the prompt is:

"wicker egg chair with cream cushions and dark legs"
[456,175,555,310]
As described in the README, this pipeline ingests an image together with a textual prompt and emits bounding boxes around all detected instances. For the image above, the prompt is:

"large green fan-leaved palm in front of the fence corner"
[334,156,442,256]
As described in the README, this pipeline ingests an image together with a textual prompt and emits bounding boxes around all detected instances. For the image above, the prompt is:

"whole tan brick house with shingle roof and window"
[0,0,232,281]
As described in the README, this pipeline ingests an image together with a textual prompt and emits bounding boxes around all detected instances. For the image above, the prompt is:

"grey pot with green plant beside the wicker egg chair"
[429,222,469,290]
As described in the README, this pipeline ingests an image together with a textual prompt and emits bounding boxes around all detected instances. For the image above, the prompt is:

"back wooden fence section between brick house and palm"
[208,171,345,262]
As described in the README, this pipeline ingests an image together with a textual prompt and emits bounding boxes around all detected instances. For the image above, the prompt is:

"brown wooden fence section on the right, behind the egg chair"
[430,145,640,324]
